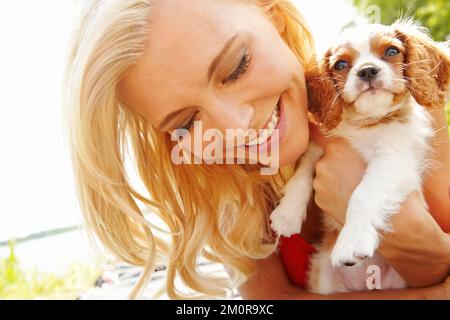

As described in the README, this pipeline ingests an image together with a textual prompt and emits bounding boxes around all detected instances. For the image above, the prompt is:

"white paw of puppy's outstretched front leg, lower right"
[331,227,378,267]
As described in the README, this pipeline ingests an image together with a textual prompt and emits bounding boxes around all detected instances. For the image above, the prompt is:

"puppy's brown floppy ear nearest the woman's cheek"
[305,49,344,131]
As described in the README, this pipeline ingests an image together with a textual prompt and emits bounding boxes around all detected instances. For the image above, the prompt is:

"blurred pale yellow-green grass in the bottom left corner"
[0,242,99,300]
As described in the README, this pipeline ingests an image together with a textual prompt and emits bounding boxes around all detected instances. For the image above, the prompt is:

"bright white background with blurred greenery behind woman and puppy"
[0,0,450,299]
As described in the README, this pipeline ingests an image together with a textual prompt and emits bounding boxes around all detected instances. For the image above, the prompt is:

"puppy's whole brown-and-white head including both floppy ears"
[307,22,450,129]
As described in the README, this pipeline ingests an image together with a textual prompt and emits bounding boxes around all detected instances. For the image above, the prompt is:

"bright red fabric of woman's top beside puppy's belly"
[280,234,316,288]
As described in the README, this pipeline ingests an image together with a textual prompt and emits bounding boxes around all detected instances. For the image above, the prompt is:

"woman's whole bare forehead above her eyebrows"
[120,0,262,122]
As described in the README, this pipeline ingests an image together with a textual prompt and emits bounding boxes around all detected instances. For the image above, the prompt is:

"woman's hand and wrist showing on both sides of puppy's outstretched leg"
[311,123,450,286]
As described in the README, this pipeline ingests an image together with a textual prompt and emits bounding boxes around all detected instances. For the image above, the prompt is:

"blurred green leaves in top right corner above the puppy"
[353,0,450,41]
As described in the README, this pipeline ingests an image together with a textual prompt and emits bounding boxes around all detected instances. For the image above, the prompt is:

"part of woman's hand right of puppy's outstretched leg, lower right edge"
[378,193,450,289]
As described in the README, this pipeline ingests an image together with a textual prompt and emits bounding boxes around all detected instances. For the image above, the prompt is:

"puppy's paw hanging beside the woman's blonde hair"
[270,201,306,237]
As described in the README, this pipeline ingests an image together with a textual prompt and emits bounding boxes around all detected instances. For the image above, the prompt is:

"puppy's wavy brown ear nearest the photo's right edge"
[393,20,450,108]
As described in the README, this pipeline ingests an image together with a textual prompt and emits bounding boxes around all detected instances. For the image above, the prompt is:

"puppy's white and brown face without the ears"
[327,25,407,117]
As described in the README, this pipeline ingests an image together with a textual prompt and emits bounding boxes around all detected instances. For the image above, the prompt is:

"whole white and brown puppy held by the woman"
[271,22,450,294]
